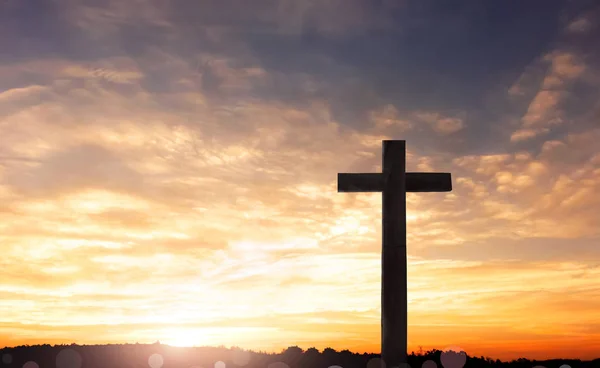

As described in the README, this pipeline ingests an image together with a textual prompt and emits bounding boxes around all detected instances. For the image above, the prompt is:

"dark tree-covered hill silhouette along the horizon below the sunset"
[0,342,600,368]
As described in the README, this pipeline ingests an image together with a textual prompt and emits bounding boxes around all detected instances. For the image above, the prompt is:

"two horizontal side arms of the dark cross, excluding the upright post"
[338,172,452,193]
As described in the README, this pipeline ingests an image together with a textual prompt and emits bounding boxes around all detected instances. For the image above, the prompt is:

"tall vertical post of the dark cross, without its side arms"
[381,141,408,367]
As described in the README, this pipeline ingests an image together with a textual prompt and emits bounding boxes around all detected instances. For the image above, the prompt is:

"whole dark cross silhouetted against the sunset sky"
[338,140,452,368]
